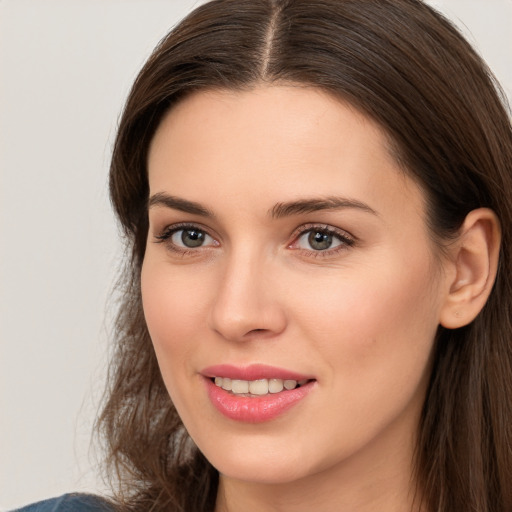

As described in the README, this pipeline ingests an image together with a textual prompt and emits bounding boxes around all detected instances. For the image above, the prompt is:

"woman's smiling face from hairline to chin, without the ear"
[142,86,448,483]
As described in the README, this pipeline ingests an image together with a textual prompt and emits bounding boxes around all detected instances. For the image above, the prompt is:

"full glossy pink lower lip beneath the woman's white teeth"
[205,378,315,423]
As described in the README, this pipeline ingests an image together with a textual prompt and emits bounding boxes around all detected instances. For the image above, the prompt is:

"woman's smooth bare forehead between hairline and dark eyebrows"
[148,85,423,223]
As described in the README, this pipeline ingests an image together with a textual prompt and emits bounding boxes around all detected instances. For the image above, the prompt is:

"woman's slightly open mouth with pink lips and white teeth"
[201,365,316,423]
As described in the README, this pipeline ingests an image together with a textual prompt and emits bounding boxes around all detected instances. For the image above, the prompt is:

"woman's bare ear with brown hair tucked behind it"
[440,208,501,329]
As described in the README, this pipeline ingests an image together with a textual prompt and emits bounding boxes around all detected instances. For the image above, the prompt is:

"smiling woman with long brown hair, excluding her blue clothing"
[15,0,512,512]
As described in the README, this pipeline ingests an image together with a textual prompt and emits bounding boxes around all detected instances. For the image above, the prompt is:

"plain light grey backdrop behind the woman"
[0,0,512,510]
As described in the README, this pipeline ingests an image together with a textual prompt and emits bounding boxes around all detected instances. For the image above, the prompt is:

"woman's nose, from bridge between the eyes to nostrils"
[210,252,287,341]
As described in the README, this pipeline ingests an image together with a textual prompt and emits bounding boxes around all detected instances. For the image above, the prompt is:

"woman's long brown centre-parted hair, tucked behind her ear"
[98,0,512,512]
